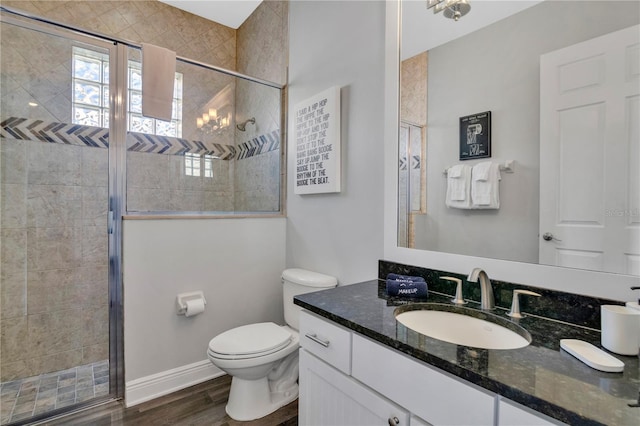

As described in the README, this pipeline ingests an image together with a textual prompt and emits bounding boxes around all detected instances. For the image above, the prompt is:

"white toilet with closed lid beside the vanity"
[207,269,338,421]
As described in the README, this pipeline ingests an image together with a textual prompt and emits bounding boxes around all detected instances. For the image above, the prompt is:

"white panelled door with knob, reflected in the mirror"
[539,26,640,275]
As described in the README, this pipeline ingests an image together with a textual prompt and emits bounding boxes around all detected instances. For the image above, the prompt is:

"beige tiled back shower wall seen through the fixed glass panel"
[122,49,238,212]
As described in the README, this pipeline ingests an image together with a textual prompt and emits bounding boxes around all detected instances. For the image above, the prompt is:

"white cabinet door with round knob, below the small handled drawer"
[298,349,409,426]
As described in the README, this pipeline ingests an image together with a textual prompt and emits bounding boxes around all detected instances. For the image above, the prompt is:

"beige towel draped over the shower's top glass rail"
[142,43,176,121]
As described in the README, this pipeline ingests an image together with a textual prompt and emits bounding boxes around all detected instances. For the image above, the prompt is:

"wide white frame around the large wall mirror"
[383,0,640,301]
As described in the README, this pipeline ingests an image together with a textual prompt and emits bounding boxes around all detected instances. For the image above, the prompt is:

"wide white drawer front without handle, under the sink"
[351,334,495,425]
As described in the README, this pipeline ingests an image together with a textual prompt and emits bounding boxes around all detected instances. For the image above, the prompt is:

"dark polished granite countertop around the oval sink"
[295,280,640,426]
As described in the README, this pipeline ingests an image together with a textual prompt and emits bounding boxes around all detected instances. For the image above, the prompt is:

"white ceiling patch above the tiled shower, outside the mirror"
[160,0,262,29]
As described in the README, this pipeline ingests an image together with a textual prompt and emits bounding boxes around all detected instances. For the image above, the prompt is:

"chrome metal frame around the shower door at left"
[0,6,127,412]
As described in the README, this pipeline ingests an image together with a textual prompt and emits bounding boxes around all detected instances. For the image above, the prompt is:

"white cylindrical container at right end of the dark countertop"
[600,305,640,355]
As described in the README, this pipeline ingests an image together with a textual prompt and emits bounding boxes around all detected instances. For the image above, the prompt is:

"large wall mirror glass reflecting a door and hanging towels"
[397,0,640,276]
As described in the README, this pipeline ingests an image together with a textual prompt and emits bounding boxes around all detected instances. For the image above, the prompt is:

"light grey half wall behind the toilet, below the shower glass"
[123,218,286,405]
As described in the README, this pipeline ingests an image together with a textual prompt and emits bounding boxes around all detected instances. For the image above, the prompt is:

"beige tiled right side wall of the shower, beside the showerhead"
[234,1,289,212]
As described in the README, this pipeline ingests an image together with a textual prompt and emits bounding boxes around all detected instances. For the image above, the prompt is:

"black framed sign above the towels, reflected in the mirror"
[460,111,491,160]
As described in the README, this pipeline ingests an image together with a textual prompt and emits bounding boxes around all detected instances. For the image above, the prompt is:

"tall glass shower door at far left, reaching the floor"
[0,12,116,425]
